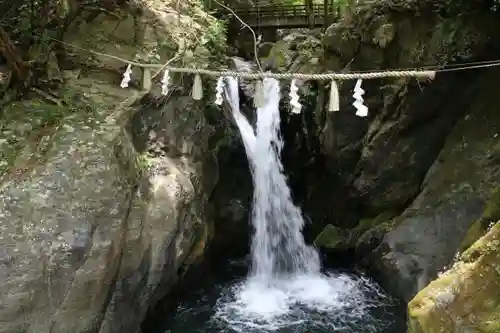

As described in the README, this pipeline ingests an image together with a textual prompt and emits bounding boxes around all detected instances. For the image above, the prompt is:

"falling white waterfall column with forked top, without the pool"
[226,78,320,281]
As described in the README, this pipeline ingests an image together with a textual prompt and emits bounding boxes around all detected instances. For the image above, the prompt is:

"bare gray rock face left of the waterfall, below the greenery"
[0,68,217,333]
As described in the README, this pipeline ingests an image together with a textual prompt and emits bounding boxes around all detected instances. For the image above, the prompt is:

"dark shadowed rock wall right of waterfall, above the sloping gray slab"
[318,1,495,214]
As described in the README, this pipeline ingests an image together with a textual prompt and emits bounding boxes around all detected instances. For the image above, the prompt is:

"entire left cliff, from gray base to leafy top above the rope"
[0,1,224,333]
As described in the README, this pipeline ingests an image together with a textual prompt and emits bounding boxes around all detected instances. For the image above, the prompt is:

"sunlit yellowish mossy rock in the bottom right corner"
[408,223,500,333]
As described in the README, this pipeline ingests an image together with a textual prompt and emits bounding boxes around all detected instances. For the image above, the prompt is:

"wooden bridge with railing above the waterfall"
[212,4,334,30]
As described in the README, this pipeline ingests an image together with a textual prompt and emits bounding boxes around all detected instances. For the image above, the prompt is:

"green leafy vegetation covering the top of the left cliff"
[0,0,227,176]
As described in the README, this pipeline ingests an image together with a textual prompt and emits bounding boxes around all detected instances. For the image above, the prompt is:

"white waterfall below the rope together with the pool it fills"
[153,78,402,333]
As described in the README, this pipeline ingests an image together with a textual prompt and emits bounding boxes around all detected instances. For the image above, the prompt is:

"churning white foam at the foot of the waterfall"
[213,274,390,332]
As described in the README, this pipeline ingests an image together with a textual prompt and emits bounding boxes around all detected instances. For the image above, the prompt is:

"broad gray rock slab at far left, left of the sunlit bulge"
[0,76,139,332]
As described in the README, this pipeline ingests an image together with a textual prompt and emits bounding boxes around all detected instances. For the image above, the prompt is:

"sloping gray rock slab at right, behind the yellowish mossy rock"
[374,73,500,301]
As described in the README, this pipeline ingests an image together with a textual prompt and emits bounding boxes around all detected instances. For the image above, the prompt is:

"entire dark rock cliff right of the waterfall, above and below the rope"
[310,1,500,301]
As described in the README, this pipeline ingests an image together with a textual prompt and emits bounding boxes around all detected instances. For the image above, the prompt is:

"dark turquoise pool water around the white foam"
[152,261,406,333]
